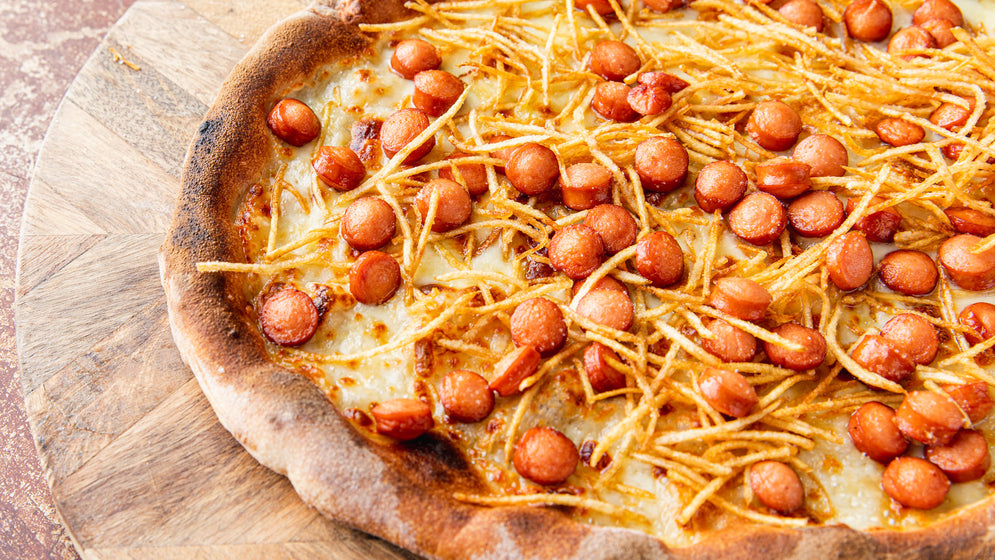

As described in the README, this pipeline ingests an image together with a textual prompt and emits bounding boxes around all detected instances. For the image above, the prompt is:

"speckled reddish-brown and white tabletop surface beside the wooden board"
[0,0,134,560]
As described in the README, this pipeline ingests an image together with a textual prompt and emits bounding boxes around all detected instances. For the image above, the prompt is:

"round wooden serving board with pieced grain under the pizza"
[15,0,413,560]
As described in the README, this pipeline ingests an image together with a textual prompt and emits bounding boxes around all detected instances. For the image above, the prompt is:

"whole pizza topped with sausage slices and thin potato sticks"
[160,0,995,558]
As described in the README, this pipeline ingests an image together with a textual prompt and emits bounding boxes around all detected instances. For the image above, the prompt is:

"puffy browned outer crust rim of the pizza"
[160,0,995,560]
